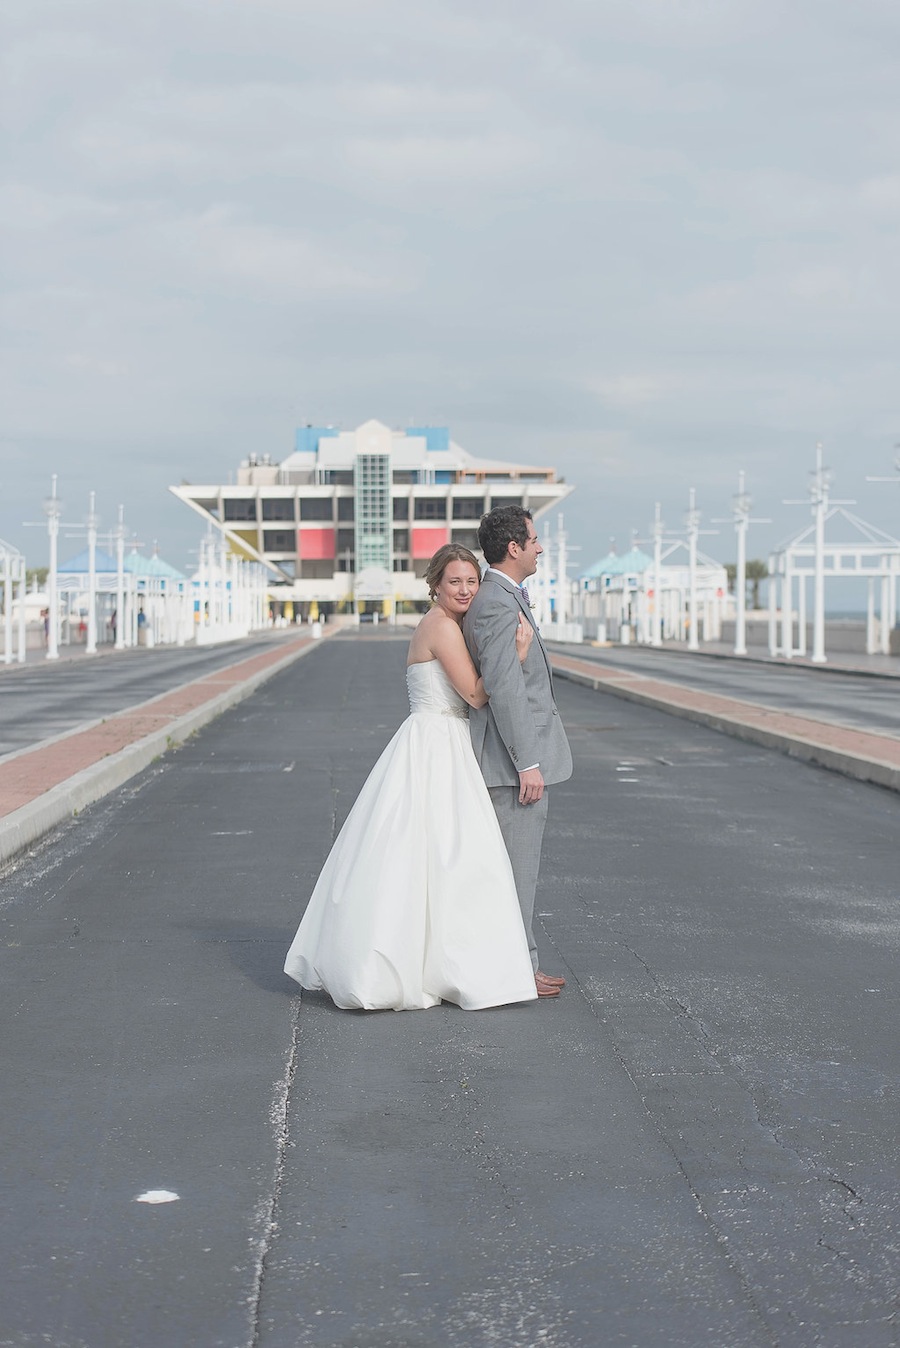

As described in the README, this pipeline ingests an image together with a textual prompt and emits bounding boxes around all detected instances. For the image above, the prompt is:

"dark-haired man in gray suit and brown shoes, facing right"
[463,506,571,998]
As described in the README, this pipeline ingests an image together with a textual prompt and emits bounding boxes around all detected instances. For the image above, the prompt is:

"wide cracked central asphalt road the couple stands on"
[0,639,900,1348]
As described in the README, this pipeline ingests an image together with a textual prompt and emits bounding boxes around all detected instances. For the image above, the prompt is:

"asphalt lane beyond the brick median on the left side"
[0,632,305,754]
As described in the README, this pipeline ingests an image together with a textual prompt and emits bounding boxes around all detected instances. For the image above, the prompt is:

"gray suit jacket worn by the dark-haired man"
[462,572,571,786]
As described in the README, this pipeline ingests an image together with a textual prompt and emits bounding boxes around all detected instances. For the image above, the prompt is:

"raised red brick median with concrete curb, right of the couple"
[552,652,900,791]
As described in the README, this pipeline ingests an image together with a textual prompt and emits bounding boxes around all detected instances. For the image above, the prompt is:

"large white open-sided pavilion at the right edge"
[769,506,900,665]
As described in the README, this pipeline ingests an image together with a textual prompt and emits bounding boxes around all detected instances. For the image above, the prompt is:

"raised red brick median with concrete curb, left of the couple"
[0,636,317,863]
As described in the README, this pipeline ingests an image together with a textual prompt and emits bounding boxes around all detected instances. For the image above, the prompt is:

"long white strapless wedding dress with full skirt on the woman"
[284,661,536,1011]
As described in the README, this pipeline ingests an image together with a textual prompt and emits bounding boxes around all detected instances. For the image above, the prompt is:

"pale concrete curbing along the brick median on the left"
[0,642,321,865]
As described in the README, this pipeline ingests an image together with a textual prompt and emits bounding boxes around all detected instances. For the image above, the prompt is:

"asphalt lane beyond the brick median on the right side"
[552,646,900,736]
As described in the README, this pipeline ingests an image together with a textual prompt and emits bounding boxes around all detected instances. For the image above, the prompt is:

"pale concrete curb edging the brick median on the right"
[554,665,900,791]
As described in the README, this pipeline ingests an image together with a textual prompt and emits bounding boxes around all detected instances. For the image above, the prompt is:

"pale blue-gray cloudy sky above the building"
[0,0,900,582]
